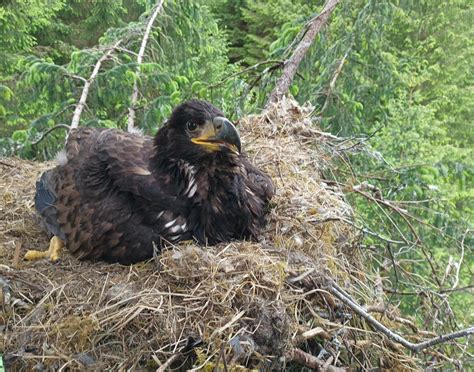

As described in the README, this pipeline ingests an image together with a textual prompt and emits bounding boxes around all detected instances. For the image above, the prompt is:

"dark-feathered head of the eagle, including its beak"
[155,99,241,163]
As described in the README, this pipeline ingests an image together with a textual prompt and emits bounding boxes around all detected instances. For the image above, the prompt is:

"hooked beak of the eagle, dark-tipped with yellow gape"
[191,116,241,154]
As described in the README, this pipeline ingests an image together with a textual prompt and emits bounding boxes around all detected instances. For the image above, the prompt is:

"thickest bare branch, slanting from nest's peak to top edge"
[266,0,340,107]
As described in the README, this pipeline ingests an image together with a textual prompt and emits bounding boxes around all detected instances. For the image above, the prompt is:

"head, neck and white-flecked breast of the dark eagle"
[151,100,273,244]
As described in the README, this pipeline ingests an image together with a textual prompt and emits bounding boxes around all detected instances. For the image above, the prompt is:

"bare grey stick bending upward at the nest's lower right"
[329,280,474,353]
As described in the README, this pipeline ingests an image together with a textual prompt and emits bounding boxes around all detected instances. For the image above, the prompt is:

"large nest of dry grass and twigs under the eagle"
[0,100,417,370]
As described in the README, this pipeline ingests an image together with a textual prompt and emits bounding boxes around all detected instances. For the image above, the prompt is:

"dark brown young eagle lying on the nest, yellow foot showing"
[25,100,274,264]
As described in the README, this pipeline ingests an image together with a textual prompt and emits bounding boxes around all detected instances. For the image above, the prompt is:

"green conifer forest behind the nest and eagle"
[0,0,474,348]
